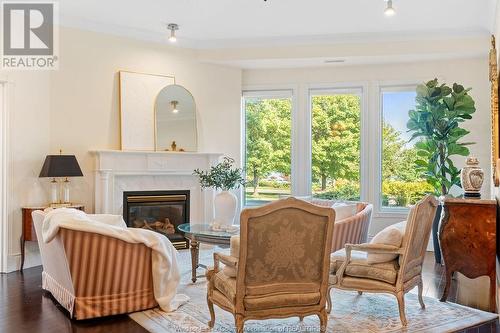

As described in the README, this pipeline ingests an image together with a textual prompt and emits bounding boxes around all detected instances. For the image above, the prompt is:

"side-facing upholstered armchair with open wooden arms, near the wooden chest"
[327,195,438,326]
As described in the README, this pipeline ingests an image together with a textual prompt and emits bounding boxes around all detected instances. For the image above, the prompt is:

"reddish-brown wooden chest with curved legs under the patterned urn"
[439,198,497,312]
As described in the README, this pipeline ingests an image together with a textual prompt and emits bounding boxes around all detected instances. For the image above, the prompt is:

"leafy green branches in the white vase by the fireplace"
[193,157,245,191]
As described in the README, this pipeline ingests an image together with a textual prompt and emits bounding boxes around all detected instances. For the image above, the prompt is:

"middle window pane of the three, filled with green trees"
[310,89,361,200]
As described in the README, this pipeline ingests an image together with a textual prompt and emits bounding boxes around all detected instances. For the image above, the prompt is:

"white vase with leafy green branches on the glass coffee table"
[193,157,245,225]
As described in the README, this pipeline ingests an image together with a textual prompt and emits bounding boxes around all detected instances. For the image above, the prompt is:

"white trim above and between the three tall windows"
[240,78,428,219]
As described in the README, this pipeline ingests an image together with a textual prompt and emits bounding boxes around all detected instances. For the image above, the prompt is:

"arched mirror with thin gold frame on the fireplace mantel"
[155,84,198,151]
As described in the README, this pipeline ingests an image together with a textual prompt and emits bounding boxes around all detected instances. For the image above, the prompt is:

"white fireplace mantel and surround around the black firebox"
[92,150,222,224]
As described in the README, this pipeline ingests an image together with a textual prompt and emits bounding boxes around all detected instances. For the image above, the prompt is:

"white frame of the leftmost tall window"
[239,85,300,209]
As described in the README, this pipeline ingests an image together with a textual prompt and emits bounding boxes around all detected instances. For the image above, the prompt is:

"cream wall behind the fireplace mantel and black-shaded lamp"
[2,28,241,269]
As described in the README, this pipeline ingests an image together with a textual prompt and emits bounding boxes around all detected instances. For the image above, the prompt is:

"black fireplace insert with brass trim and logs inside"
[123,191,190,250]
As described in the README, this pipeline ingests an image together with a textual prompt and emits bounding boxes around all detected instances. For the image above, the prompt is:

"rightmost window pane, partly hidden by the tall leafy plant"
[381,86,432,207]
